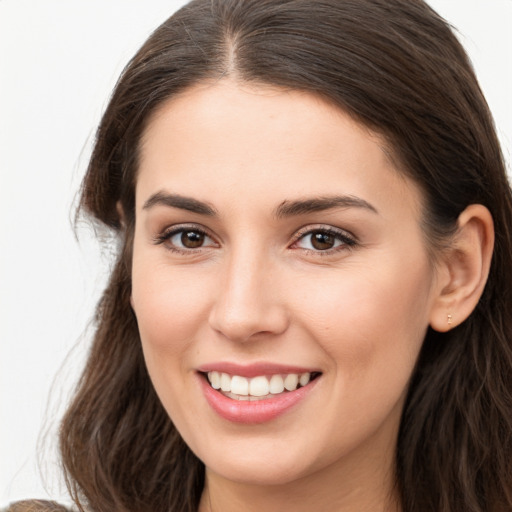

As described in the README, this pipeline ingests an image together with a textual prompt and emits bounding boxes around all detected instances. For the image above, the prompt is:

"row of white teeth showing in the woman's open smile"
[201,370,321,402]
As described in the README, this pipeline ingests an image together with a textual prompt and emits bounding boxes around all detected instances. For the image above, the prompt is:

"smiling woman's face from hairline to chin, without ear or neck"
[132,80,436,484]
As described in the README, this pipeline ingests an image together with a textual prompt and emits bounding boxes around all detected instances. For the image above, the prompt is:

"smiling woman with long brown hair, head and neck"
[5,0,512,511]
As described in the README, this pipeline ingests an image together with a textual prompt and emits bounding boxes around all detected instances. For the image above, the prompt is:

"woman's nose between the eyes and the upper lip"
[209,250,288,342]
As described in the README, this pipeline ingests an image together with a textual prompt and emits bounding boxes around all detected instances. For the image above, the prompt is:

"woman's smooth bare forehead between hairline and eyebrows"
[137,80,420,218]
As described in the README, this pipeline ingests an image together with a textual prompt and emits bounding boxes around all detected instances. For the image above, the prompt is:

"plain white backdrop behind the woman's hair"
[0,0,512,506]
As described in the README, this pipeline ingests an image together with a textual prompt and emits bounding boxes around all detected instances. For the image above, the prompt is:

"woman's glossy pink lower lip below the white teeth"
[199,375,319,424]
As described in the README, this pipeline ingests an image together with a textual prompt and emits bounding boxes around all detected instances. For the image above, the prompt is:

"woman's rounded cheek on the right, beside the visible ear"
[296,258,431,382]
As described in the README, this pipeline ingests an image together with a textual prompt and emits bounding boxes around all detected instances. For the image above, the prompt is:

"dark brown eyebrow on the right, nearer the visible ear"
[274,196,379,219]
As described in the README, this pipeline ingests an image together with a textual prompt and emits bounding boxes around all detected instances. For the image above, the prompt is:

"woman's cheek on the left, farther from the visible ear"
[132,255,214,418]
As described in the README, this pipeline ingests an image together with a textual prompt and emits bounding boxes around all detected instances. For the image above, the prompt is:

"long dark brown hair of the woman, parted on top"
[60,0,512,512]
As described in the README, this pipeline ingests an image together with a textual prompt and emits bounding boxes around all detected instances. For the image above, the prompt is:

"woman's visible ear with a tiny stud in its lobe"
[430,204,494,332]
